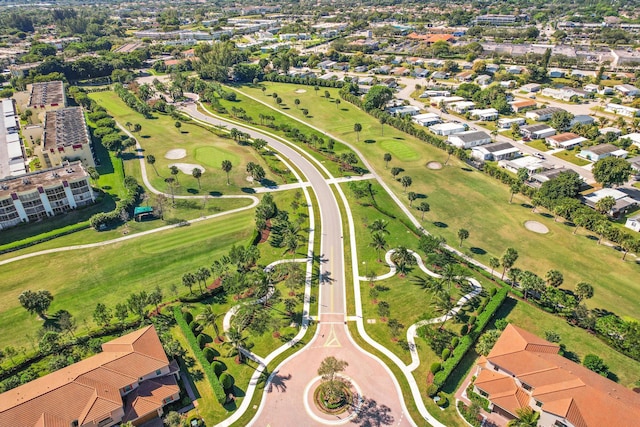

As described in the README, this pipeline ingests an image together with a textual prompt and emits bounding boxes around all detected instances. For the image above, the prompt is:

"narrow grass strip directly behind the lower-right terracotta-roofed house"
[496,298,640,387]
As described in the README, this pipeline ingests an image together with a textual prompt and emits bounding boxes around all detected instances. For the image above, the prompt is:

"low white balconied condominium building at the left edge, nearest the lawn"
[0,161,95,231]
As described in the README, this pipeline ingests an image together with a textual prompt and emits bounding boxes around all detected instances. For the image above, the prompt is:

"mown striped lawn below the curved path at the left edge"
[0,210,253,347]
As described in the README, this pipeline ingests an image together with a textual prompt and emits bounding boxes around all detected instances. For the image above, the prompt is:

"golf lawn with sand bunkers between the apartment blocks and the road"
[90,91,282,194]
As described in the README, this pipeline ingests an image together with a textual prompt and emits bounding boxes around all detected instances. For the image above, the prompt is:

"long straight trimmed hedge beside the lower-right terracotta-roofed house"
[433,288,509,388]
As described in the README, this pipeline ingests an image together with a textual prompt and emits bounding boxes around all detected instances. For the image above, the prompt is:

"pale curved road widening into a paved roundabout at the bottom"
[182,103,415,426]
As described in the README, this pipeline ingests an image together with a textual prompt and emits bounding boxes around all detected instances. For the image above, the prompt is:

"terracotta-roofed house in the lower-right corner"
[474,325,640,427]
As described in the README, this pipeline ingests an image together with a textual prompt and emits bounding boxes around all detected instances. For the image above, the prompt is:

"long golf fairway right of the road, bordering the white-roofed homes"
[234,83,640,318]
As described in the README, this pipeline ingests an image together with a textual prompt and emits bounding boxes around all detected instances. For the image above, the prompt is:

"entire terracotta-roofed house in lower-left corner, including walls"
[0,326,180,427]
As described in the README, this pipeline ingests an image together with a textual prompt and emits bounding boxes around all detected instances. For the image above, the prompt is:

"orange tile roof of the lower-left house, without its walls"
[0,326,174,427]
